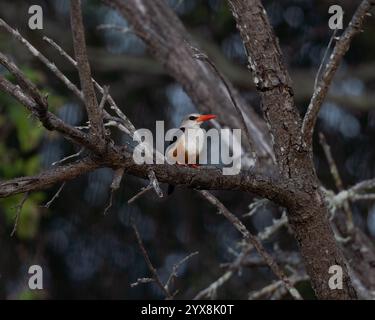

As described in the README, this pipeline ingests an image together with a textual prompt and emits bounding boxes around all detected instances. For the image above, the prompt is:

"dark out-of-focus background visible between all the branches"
[0,0,375,299]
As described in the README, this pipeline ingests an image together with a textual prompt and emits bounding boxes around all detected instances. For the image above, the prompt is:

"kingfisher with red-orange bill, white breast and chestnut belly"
[166,113,216,195]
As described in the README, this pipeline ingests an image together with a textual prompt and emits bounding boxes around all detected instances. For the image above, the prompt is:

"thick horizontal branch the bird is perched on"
[0,145,287,202]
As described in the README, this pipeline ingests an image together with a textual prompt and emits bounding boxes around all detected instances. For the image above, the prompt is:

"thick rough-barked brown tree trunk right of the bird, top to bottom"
[229,0,356,299]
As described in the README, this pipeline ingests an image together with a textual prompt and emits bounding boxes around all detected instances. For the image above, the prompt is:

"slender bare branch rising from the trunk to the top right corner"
[301,0,374,149]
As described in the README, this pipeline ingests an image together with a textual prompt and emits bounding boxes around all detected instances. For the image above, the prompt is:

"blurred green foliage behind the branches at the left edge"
[0,67,64,239]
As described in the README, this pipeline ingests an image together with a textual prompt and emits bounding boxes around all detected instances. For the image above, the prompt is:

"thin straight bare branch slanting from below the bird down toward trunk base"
[199,190,302,300]
